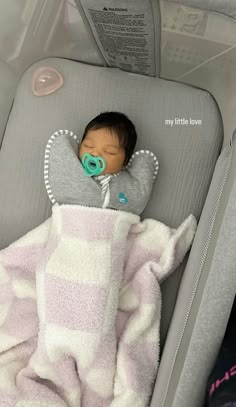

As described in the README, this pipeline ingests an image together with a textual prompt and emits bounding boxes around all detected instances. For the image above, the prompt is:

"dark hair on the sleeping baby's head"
[82,112,137,165]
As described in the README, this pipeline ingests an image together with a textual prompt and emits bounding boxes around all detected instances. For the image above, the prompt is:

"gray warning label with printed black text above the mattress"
[80,0,155,76]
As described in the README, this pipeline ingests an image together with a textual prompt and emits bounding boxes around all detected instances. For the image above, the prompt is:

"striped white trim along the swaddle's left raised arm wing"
[44,129,80,205]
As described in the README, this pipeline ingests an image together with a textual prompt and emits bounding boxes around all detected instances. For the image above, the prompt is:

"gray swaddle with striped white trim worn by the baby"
[44,130,159,215]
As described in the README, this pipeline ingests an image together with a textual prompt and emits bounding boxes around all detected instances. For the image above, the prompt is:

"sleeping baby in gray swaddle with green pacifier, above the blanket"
[45,112,159,215]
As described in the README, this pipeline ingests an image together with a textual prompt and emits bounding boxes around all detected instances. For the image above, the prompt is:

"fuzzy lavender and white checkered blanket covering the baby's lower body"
[0,205,196,407]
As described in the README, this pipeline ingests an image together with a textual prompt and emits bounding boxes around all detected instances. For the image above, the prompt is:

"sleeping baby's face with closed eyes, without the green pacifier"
[79,127,125,174]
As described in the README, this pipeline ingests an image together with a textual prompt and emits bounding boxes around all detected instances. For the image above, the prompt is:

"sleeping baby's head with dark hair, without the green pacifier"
[78,112,137,175]
